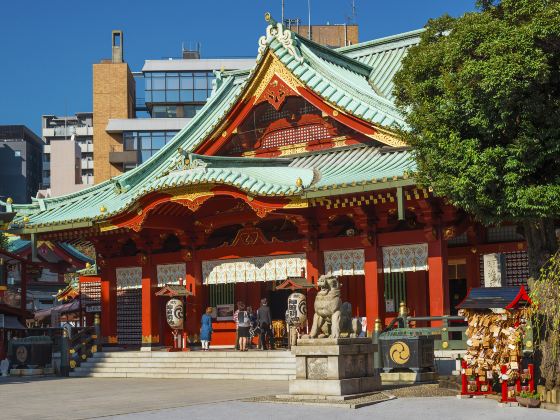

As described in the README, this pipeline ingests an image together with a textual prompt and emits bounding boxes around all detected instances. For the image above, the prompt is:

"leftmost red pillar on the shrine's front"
[100,265,117,344]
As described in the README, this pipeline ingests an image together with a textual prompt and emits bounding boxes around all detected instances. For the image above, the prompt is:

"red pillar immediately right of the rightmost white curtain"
[428,229,449,316]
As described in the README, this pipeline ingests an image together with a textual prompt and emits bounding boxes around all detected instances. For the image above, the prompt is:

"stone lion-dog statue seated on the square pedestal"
[309,275,361,338]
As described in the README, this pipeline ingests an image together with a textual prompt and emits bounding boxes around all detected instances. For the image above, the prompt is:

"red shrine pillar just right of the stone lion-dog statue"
[364,246,385,335]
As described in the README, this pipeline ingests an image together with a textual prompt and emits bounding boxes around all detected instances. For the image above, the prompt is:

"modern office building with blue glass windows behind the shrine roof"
[103,53,254,172]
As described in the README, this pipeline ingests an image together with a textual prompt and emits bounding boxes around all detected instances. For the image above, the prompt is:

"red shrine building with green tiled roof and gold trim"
[1,18,528,347]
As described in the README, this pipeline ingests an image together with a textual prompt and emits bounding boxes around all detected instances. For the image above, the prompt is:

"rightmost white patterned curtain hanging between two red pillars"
[383,243,428,273]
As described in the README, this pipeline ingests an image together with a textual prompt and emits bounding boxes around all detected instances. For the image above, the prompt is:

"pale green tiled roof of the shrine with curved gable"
[0,23,418,232]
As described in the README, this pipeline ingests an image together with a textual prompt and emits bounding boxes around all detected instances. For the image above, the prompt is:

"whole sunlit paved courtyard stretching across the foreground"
[0,378,560,420]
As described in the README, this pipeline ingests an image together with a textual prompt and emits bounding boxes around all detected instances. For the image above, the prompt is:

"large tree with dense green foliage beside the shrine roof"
[395,0,560,278]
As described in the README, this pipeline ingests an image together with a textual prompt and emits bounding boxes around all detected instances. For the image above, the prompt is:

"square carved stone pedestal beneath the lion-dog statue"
[289,338,381,395]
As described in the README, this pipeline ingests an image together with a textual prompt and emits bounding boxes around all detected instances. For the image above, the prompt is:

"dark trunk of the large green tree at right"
[523,219,558,279]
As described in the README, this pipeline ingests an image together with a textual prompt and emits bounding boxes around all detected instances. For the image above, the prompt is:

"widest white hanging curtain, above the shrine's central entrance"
[202,254,307,284]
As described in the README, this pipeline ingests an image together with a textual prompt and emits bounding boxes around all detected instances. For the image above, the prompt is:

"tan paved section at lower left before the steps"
[0,377,288,420]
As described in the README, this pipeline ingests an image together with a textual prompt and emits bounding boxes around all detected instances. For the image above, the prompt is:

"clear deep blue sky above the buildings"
[0,0,474,135]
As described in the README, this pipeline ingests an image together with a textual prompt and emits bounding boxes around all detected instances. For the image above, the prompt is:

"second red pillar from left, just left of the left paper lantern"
[142,257,160,349]
